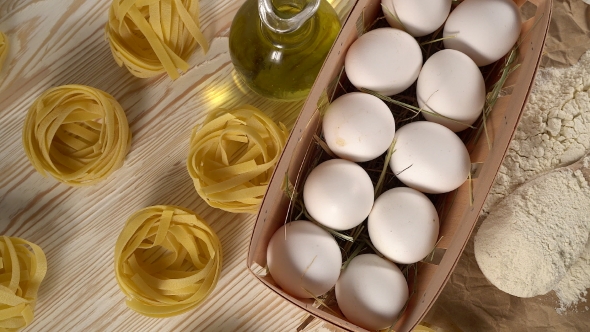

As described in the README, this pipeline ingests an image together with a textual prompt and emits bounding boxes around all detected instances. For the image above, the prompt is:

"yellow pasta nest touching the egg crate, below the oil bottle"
[187,105,289,213]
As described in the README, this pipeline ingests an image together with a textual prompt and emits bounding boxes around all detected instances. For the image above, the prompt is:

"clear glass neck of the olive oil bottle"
[258,0,320,34]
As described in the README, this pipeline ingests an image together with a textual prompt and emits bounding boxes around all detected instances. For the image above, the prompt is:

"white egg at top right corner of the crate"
[443,0,521,67]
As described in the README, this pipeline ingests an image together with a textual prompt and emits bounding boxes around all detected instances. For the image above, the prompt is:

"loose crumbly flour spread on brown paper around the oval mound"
[484,52,590,312]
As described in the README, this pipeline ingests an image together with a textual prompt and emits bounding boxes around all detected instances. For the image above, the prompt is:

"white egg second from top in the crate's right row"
[416,50,486,132]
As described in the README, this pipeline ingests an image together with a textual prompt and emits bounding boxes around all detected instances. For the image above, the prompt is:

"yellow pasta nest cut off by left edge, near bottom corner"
[0,236,47,331]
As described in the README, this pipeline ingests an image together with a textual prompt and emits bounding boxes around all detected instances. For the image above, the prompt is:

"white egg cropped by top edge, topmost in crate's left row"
[381,0,452,37]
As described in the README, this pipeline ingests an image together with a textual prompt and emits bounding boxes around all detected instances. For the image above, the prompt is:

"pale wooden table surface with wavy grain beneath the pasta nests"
[0,0,350,331]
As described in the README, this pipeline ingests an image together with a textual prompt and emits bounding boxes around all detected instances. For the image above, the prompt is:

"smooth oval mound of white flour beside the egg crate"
[474,169,590,297]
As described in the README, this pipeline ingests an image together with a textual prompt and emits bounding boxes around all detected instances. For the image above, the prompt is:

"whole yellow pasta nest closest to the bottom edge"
[115,205,221,317]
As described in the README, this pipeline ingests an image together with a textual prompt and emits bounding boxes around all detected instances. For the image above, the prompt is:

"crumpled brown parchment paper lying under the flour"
[424,0,590,332]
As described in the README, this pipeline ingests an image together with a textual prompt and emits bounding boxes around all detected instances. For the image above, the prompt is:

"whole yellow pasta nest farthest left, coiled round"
[23,85,131,186]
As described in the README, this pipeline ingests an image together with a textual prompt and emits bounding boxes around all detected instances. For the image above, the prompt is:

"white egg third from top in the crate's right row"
[389,121,471,194]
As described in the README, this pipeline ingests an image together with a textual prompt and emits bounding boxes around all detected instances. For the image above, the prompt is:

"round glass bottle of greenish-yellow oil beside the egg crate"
[229,0,340,100]
